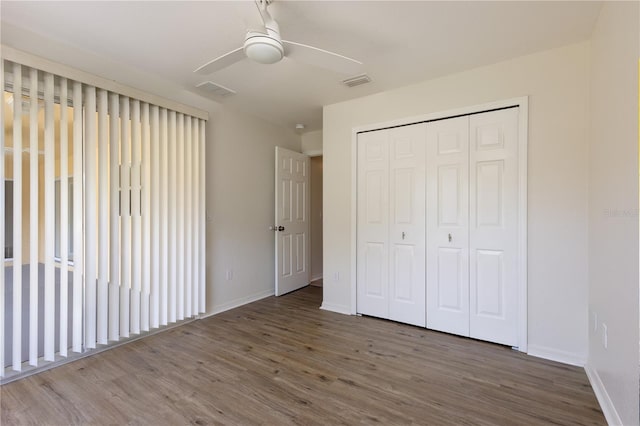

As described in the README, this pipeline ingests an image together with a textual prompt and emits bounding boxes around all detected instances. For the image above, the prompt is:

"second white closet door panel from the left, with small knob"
[389,124,426,327]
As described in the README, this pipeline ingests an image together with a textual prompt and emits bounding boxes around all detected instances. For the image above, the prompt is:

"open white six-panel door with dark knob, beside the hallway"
[273,147,310,296]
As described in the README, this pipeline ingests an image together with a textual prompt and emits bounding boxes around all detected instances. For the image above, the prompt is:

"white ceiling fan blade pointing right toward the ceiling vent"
[282,40,362,75]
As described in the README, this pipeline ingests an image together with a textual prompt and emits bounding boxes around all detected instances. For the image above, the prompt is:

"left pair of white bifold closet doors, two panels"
[357,124,426,326]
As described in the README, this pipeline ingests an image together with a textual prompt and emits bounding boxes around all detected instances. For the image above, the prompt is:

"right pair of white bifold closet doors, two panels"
[427,108,518,346]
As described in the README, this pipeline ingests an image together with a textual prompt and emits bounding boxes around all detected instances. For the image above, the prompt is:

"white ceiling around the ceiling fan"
[0,0,601,130]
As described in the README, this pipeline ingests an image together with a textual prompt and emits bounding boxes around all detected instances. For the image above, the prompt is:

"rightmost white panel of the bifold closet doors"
[469,108,518,346]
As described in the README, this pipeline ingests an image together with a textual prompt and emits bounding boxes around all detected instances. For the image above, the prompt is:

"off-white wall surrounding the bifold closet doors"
[323,42,589,364]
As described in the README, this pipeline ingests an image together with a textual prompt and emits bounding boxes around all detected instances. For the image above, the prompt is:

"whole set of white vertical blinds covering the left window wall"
[0,60,206,377]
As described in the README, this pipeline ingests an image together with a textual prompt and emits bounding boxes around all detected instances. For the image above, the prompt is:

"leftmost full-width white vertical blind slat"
[12,64,22,371]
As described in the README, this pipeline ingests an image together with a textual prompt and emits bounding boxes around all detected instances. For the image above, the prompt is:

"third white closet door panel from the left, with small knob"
[427,116,469,336]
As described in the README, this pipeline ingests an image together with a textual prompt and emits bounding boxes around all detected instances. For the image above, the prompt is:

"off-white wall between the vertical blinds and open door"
[206,108,300,313]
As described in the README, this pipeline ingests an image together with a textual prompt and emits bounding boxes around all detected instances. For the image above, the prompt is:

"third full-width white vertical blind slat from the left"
[44,73,56,361]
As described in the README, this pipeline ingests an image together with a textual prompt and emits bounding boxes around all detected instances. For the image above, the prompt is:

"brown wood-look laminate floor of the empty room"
[0,287,606,426]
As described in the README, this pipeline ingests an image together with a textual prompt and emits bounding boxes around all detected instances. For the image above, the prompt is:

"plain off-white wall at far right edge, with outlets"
[587,2,640,425]
